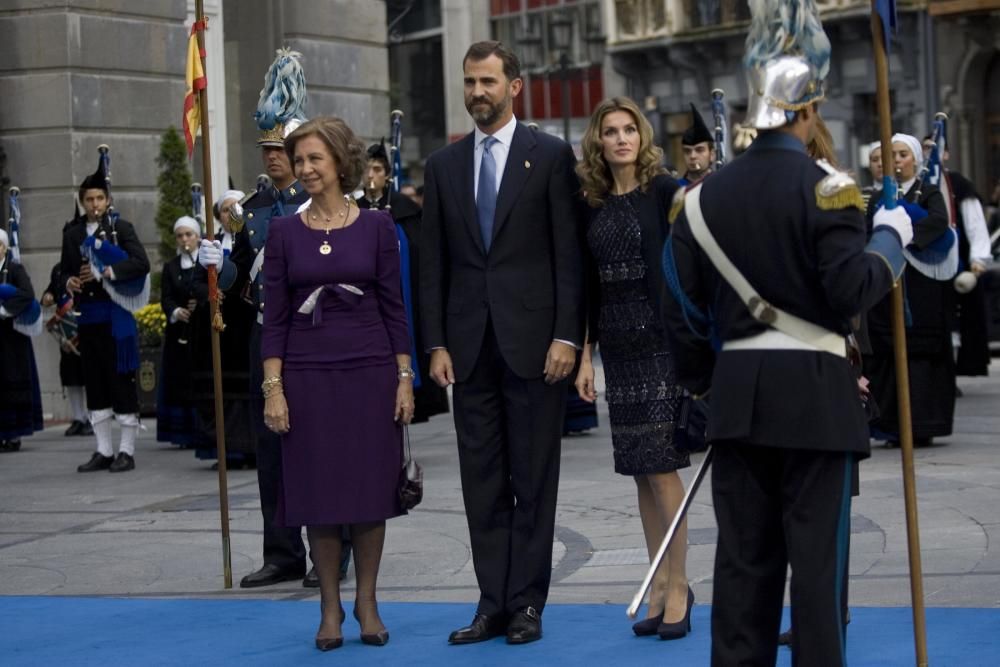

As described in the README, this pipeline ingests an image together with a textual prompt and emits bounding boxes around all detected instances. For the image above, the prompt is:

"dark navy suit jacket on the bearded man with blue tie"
[420,124,584,381]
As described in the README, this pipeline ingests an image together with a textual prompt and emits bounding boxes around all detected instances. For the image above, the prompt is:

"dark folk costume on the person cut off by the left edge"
[0,229,44,452]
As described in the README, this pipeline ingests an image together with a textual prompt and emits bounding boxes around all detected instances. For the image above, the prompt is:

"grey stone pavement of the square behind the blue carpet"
[0,363,1000,620]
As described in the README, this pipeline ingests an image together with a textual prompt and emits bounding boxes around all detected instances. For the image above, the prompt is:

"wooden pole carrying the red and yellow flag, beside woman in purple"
[194,0,233,588]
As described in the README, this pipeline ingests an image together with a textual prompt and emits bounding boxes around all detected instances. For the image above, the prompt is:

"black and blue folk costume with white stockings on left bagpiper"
[59,164,149,472]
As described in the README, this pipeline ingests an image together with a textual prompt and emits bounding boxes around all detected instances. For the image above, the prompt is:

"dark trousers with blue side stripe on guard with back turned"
[712,442,853,667]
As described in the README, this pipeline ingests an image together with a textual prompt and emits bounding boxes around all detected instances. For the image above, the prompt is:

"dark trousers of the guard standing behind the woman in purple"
[250,324,306,573]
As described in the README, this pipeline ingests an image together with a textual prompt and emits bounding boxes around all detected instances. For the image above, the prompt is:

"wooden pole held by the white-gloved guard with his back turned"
[871,0,927,667]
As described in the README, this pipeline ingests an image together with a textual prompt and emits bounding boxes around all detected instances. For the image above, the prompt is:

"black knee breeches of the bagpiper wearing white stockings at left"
[79,322,139,415]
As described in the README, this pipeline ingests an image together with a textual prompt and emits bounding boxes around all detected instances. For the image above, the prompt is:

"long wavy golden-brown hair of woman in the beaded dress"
[576,97,667,208]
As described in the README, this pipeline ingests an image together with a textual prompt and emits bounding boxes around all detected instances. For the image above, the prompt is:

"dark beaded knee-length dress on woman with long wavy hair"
[587,189,690,475]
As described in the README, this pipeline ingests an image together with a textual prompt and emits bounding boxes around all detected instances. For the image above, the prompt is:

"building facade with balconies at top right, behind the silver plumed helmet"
[604,0,1000,188]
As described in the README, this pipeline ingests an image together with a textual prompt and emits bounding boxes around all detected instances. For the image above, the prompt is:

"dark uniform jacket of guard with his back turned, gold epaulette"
[669,132,902,454]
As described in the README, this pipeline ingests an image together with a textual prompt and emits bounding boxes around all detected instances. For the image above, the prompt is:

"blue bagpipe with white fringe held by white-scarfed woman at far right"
[900,113,959,281]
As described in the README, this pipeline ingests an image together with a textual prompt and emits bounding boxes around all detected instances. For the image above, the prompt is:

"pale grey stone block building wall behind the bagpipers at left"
[0,0,389,418]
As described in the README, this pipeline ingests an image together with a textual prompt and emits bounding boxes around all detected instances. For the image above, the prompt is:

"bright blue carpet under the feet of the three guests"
[0,597,1000,667]
